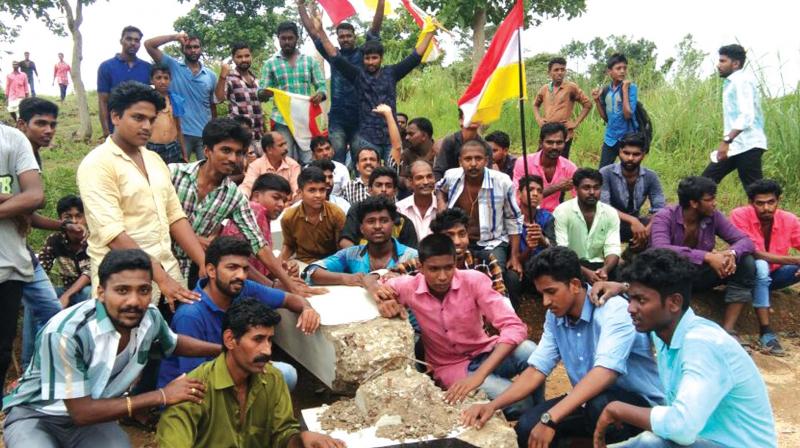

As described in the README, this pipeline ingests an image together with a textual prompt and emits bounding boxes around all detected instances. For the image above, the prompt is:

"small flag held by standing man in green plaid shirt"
[268,88,328,151]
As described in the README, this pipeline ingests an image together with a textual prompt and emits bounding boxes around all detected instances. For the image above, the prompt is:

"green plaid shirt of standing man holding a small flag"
[259,52,326,125]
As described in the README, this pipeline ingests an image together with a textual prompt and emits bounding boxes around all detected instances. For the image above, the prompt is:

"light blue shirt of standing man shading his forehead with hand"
[161,53,217,137]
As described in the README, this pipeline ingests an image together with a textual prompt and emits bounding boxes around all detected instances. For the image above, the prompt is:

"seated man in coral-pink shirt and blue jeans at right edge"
[731,179,800,355]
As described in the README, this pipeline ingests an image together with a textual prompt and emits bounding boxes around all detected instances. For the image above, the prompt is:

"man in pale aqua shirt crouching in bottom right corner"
[594,249,777,448]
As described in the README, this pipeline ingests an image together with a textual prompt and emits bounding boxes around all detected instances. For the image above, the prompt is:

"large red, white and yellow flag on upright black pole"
[458,0,527,125]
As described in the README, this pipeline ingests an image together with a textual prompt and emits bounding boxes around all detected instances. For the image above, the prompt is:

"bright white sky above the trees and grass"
[0,0,800,95]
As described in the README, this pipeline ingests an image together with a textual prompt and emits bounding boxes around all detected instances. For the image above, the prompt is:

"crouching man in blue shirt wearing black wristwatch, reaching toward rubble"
[462,247,664,447]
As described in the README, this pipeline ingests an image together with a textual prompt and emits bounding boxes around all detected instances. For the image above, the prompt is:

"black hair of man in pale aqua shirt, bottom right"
[620,248,696,311]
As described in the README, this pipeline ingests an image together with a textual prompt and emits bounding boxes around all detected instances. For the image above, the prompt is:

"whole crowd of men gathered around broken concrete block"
[0,7,784,448]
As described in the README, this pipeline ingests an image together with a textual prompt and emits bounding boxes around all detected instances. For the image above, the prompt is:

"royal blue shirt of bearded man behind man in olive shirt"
[158,279,286,387]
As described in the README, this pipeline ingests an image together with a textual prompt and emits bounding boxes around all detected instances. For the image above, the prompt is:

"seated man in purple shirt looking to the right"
[648,176,756,336]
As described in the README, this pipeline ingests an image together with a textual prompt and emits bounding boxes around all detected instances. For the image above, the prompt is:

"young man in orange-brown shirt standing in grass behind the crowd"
[533,57,592,159]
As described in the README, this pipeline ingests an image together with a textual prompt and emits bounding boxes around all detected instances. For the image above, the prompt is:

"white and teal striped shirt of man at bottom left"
[3,300,178,416]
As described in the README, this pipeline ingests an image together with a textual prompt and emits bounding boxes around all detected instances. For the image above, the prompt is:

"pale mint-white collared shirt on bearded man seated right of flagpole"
[553,198,622,263]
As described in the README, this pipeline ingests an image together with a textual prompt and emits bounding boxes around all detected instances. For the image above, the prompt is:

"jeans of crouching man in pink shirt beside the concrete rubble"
[467,339,544,420]
